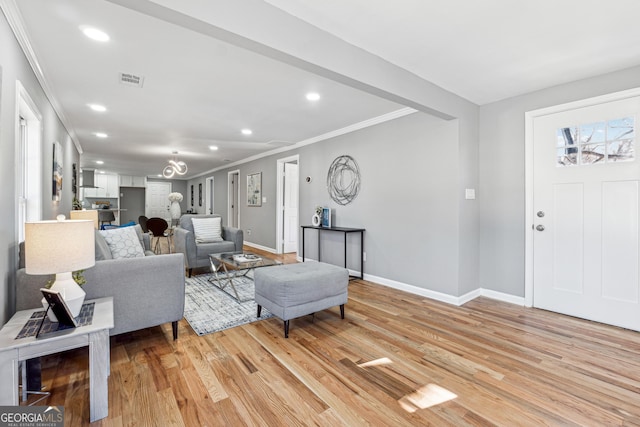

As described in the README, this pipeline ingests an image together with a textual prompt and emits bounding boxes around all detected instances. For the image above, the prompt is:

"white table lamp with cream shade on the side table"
[24,215,96,317]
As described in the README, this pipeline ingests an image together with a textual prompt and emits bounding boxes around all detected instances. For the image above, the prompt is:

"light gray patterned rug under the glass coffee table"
[184,274,273,336]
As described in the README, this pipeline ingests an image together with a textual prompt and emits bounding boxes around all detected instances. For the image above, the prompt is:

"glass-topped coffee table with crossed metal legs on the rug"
[209,251,282,302]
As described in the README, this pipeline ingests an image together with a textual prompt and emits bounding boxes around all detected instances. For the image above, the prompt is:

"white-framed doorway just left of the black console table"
[276,155,300,254]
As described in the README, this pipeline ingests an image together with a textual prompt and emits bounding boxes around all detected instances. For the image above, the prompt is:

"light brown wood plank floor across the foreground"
[26,247,640,426]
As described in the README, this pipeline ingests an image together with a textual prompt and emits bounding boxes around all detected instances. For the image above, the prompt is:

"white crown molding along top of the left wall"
[0,0,83,154]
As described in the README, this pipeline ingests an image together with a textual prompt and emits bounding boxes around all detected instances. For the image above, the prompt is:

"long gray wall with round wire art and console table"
[190,113,464,295]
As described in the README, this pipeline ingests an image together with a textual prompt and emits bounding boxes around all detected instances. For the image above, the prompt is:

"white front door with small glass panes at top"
[533,97,640,330]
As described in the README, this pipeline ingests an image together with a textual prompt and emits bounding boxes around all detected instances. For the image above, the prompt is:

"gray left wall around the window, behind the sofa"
[0,9,79,324]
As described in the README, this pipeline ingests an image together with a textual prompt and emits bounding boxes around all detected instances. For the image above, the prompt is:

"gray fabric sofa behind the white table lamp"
[16,225,185,339]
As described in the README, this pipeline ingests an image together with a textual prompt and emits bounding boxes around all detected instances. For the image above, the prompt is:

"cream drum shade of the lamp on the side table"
[24,220,96,274]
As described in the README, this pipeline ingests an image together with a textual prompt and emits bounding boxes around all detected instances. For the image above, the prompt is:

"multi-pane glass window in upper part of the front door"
[556,117,635,167]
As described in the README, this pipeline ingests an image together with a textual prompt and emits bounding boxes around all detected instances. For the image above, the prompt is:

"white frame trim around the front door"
[524,88,640,307]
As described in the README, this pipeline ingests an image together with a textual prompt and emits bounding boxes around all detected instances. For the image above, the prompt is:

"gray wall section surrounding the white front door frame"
[479,67,640,297]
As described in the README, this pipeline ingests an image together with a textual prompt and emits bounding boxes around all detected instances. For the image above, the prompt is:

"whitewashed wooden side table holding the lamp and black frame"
[0,297,114,422]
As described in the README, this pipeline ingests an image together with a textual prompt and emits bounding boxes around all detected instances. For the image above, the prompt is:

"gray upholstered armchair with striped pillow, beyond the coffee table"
[173,214,244,277]
